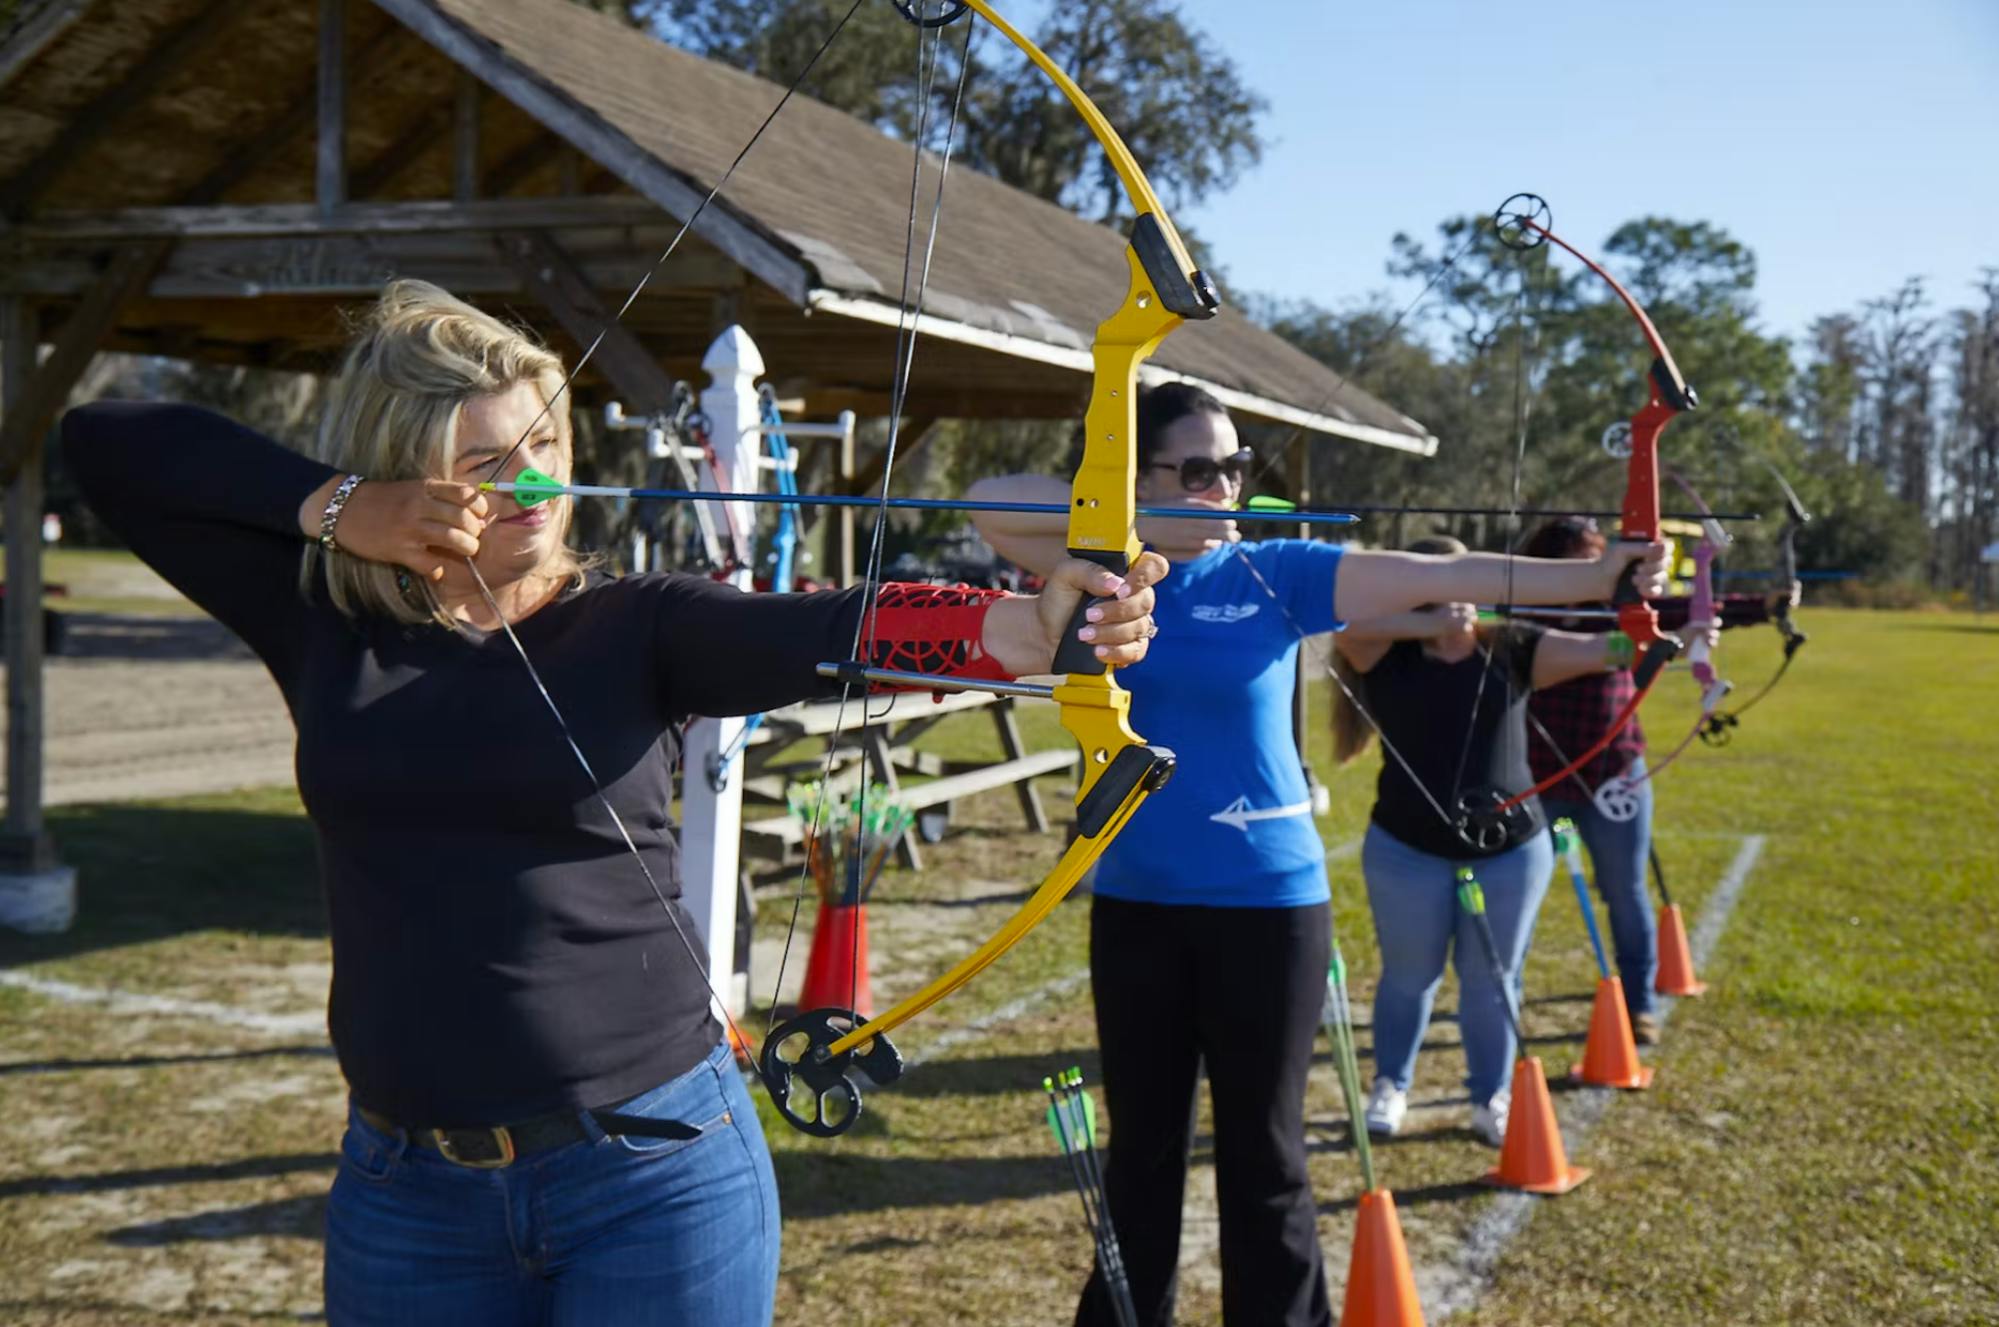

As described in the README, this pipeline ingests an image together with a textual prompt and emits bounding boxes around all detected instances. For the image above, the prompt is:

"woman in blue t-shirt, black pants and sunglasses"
[972,384,1665,1325]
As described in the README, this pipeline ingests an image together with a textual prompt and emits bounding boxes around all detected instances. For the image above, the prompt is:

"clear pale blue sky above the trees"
[1151,0,1999,347]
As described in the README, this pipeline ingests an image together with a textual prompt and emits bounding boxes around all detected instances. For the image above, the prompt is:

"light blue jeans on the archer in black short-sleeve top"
[1361,825,1555,1105]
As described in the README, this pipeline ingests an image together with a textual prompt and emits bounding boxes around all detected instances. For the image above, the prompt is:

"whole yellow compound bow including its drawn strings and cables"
[451,0,1219,1137]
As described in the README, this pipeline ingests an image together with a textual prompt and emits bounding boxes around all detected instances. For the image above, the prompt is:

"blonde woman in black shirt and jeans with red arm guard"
[64,282,1165,1327]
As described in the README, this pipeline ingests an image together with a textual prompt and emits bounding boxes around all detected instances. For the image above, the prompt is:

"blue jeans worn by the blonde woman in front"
[326,1043,778,1327]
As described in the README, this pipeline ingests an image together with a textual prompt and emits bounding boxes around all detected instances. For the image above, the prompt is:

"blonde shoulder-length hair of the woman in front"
[300,280,582,626]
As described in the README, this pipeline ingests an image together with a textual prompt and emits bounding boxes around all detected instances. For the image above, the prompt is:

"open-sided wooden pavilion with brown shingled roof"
[0,0,1435,891]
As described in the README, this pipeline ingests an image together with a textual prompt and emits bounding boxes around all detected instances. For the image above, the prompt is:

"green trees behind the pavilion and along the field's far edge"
[627,0,1999,596]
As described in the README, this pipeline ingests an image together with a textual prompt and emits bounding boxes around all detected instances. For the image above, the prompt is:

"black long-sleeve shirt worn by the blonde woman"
[62,404,862,1127]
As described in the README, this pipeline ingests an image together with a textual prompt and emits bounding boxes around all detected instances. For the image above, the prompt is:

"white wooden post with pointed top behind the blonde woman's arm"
[680,328,764,1013]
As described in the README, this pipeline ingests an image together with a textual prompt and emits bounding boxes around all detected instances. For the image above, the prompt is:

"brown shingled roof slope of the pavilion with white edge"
[409,0,1435,452]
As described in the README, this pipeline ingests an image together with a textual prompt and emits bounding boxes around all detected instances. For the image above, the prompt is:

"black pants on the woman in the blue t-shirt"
[1075,897,1333,1327]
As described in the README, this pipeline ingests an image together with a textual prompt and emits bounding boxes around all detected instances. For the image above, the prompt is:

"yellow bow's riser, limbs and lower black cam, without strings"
[762,0,1219,1135]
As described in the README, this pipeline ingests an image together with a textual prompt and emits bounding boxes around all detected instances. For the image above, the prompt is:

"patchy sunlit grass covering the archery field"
[0,610,1999,1327]
